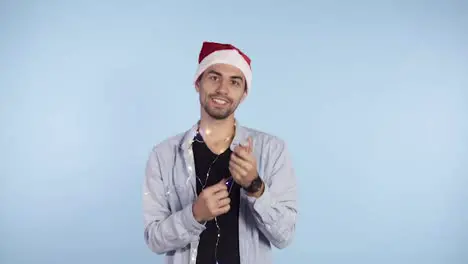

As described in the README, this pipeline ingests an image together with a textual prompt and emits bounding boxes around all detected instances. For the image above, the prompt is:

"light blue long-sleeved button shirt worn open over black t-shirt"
[143,120,297,264]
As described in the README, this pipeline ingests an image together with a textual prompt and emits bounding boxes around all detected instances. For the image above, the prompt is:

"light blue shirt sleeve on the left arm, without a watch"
[143,150,205,254]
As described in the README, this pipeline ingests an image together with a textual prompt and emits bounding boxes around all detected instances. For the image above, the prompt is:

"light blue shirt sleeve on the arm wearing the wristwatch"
[247,142,297,249]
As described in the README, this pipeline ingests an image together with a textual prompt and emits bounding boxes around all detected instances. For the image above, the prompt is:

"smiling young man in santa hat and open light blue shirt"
[143,42,297,264]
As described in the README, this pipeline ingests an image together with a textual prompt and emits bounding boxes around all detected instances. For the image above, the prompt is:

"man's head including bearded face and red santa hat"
[195,42,252,120]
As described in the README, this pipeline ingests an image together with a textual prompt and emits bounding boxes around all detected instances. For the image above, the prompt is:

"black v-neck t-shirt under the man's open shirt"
[192,134,240,264]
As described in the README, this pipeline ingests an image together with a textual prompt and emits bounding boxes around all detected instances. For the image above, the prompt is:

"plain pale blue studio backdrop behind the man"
[0,0,468,264]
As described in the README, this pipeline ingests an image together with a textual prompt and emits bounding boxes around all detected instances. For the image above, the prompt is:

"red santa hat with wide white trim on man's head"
[195,41,252,89]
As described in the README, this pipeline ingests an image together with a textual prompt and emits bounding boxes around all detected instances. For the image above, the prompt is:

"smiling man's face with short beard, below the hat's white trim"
[196,64,246,120]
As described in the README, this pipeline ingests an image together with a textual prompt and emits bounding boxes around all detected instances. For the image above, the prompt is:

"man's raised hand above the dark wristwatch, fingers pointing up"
[229,137,258,188]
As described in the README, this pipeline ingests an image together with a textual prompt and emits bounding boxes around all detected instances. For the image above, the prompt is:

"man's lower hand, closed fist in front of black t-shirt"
[192,179,231,223]
